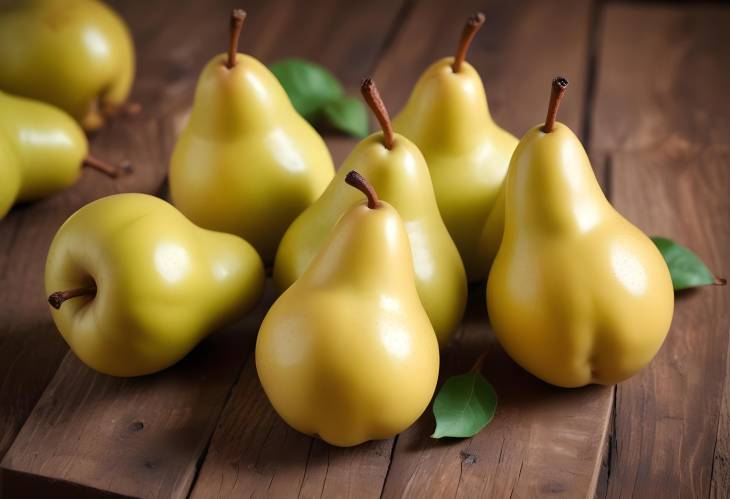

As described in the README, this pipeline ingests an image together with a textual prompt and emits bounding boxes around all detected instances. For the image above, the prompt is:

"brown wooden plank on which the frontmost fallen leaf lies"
[376,1,612,497]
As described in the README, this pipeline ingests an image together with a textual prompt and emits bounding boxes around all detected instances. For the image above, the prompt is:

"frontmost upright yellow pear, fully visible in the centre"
[256,171,439,446]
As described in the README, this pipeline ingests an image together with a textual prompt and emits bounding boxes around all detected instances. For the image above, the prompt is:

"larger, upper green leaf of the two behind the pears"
[271,59,344,122]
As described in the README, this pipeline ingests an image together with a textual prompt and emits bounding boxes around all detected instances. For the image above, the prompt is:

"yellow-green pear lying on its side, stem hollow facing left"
[45,194,264,376]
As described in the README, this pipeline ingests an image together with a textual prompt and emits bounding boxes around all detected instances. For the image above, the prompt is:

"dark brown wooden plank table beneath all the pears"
[0,0,730,498]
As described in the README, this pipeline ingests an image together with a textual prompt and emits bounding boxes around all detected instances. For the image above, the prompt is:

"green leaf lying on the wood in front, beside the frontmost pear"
[431,372,497,438]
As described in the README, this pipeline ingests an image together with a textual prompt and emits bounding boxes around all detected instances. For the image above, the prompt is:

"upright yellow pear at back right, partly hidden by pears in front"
[393,13,517,281]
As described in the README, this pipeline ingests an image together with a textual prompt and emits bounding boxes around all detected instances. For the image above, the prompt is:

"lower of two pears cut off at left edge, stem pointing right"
[0,92,131,218]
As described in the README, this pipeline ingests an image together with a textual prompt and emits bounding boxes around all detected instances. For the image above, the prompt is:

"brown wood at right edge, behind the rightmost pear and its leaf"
[593,5,730,497]
